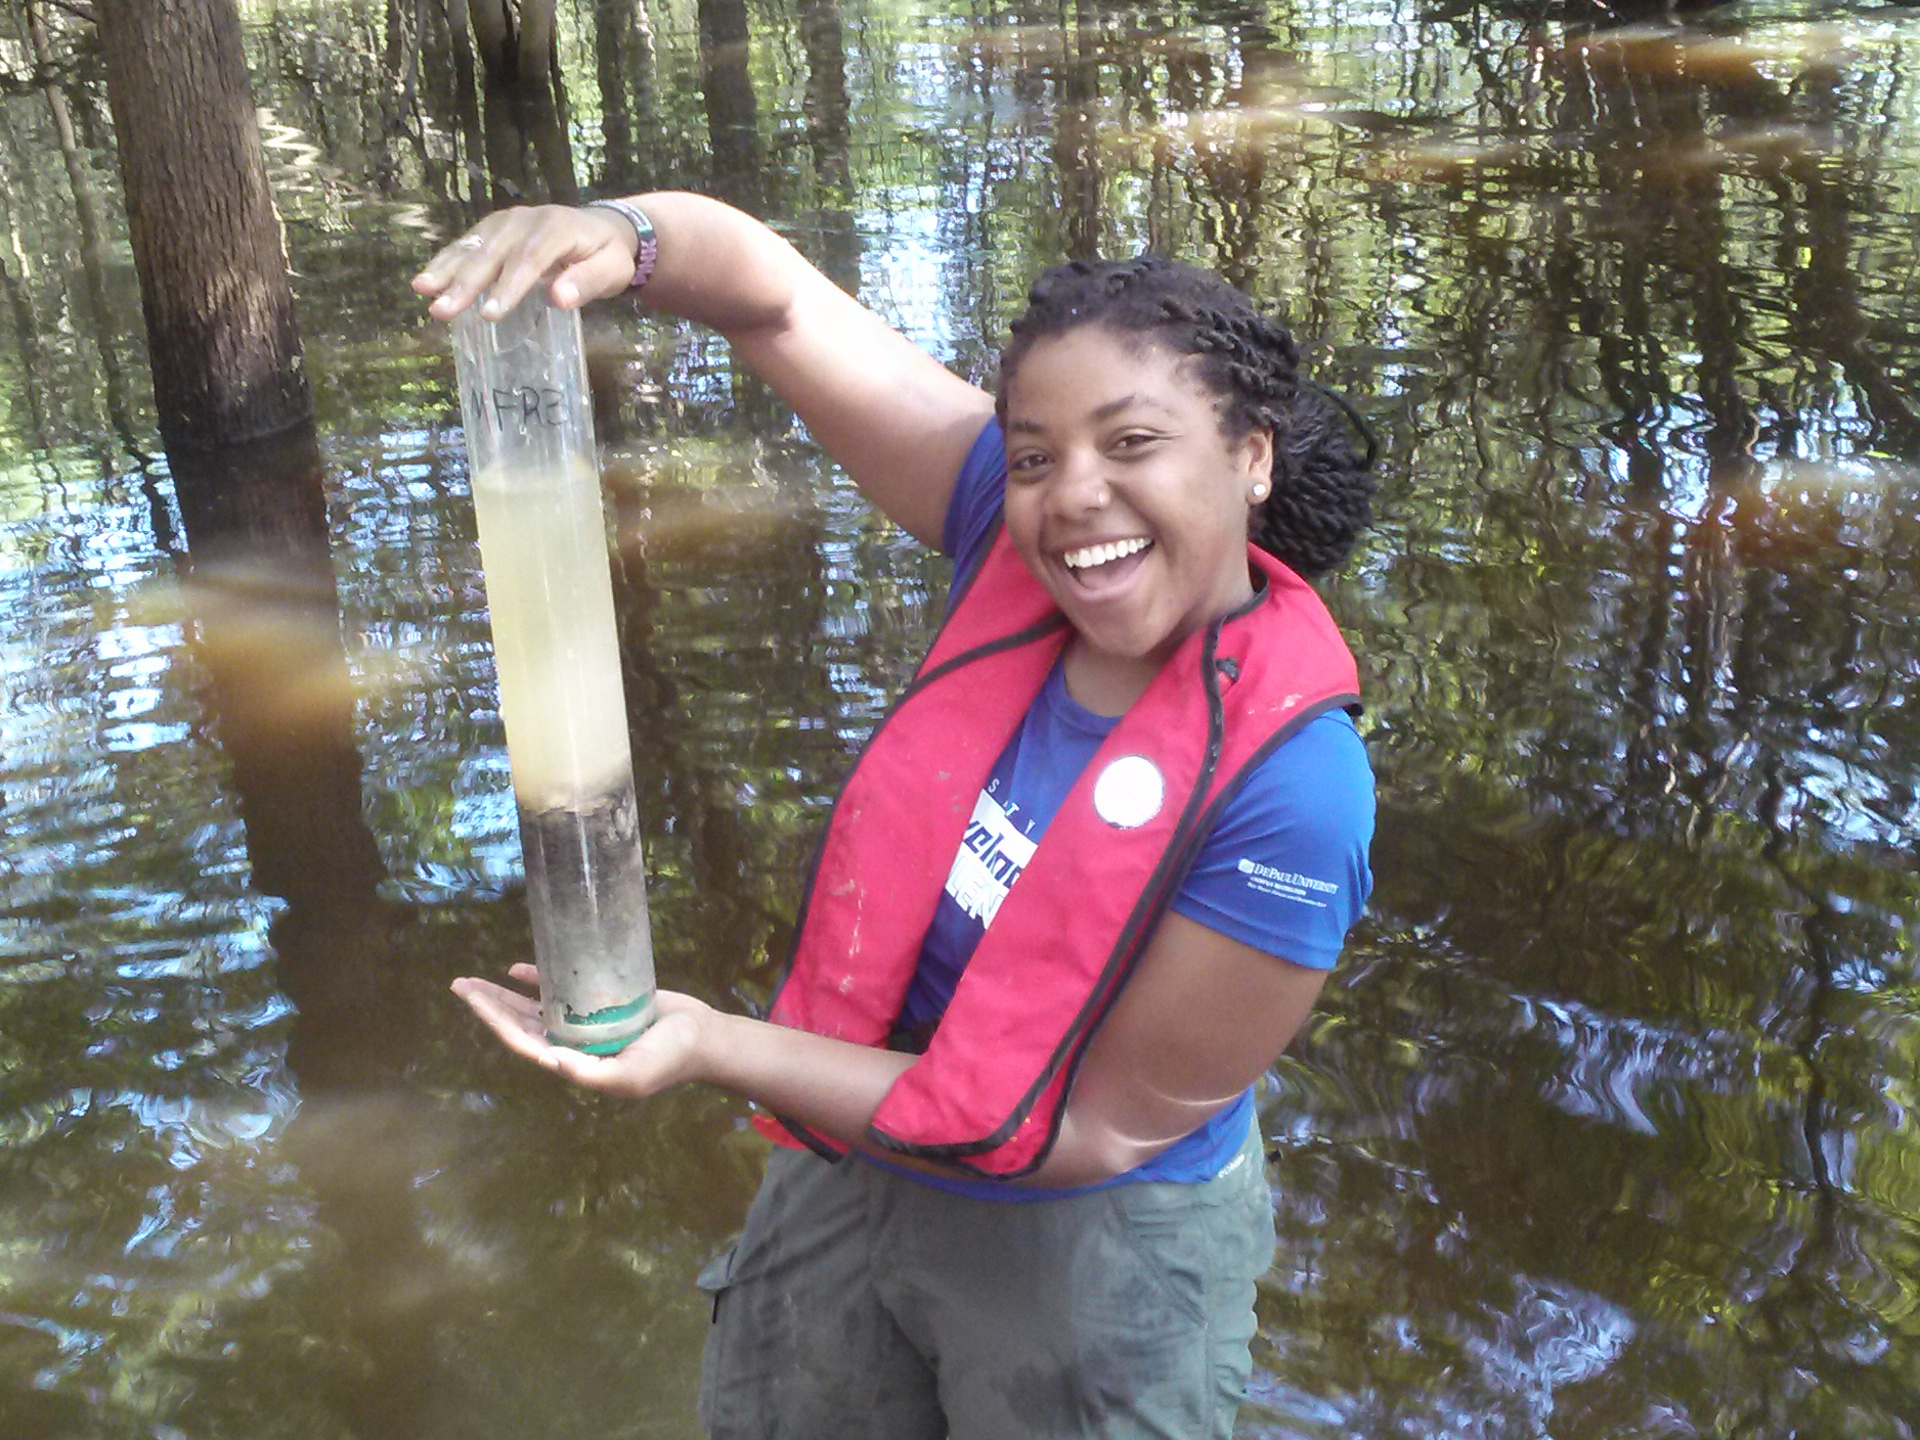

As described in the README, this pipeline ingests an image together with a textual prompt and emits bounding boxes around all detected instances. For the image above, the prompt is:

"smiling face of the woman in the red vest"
[1006,324,1273,699]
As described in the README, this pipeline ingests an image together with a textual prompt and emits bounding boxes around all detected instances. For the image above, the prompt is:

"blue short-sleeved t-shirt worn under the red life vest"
[856,422,1373,1202]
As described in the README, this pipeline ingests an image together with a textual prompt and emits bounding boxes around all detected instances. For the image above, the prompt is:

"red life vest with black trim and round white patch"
[756,532,1359,1179]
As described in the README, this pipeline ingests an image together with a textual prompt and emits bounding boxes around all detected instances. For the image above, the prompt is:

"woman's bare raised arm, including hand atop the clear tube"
[413,192,993,545]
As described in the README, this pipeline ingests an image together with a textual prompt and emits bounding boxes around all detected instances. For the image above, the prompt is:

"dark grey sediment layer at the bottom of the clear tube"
[520,780,653,1050]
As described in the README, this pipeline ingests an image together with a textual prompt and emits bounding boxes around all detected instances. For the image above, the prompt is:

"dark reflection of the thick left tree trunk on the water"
[171,428,440,1436]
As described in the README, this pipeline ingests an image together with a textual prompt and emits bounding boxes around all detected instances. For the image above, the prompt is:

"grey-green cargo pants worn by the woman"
[699,1127,1273,1440]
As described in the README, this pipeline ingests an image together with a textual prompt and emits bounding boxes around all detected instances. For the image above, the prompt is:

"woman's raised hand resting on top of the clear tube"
[413,205,636,321]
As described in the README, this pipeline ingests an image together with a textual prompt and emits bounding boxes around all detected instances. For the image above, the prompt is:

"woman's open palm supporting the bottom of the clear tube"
[453,966,714,1098]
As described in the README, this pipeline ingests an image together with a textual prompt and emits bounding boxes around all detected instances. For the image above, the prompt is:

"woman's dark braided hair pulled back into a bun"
[995,255,1375,576]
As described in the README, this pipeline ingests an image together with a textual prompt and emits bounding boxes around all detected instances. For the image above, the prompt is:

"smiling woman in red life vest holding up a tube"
[415,194,1373,1440]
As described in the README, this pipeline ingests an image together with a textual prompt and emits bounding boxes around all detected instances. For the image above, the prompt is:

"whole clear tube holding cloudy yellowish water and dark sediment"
[453,292,655,1054]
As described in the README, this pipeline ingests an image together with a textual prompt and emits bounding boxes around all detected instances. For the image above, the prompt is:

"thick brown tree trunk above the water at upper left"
[98,0,313,449]
